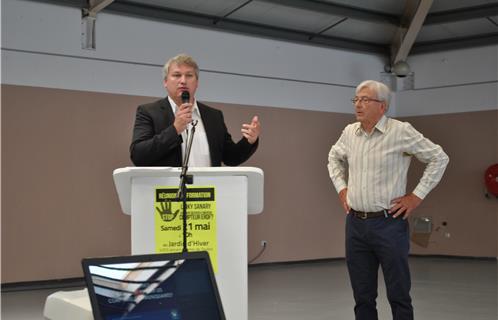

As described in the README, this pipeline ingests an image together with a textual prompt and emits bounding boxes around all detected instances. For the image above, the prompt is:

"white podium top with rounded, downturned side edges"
[112,167,264,214]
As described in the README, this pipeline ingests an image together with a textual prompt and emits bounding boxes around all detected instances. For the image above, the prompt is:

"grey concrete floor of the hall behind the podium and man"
[1,257,498,320]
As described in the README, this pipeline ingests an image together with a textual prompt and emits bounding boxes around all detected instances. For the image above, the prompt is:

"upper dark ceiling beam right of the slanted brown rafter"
[425,3,498,25]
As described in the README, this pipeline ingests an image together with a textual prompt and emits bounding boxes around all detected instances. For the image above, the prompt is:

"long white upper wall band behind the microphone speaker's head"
[2,0,384,113]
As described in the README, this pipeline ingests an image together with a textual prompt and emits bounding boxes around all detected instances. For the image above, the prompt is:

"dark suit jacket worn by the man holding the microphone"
[130,98,259,167]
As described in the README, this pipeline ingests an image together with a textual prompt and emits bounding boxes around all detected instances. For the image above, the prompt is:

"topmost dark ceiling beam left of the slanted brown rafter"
[257,0,399,26]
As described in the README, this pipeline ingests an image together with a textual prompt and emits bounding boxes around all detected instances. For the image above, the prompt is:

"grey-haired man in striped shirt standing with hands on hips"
[328,80,448,320]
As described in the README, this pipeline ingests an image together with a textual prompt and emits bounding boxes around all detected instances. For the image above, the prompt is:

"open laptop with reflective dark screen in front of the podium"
[82,251,225,320]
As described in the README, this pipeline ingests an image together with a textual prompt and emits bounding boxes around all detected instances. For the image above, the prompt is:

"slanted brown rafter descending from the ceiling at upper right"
[391,0,433,66]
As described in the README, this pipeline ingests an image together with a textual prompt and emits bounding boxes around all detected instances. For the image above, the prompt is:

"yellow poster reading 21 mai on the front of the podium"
[154,186,218,273]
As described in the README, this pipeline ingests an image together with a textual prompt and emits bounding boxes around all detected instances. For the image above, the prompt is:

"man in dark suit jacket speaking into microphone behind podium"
[130,54,260,167]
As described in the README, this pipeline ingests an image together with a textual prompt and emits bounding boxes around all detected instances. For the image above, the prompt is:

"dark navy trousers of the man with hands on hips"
[346,214,413,320]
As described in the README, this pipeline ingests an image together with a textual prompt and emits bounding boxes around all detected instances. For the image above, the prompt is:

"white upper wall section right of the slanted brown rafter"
[396,45,498,117]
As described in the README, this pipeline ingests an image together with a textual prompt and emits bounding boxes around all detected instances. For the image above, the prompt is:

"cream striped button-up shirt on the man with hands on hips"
[328,116,449,212]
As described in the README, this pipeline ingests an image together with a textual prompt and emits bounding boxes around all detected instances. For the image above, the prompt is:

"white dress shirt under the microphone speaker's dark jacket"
[168,96,211,167]
